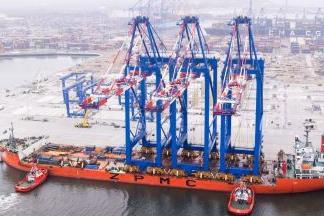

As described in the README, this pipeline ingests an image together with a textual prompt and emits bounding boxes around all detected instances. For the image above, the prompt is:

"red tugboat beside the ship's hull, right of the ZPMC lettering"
[227,184,254,215]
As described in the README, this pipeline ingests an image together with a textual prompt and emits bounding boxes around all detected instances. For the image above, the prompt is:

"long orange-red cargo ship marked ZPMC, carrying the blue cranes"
[2,120,324,194]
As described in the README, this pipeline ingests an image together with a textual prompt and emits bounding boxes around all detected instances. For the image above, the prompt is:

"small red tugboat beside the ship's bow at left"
[15,166,48,193]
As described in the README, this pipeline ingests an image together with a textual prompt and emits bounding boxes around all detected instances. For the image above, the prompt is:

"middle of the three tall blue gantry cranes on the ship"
[135,16,217,173]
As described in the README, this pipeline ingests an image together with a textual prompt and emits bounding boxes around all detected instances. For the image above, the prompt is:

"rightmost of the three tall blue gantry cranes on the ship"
[214,16,264,176]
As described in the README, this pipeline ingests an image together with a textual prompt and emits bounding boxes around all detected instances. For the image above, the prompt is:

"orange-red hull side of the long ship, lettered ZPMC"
[2,151,324,194]
